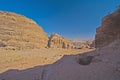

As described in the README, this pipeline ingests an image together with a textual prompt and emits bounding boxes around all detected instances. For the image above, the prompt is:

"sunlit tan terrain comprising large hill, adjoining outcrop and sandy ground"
[0,11,92,73]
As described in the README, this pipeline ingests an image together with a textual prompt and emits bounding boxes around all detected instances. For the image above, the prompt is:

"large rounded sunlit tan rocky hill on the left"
[0,11,48,50]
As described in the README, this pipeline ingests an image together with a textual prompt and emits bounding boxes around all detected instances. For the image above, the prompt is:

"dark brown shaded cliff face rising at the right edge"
[95,9,120,48]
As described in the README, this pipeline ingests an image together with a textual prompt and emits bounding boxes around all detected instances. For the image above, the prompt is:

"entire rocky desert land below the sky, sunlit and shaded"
[0,8,120,80]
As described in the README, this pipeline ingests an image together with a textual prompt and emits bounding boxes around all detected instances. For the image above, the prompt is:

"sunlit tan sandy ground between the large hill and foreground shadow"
[0,49,92,73]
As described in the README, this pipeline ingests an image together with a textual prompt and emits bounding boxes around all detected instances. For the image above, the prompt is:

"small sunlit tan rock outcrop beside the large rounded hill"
[48,34,74,49]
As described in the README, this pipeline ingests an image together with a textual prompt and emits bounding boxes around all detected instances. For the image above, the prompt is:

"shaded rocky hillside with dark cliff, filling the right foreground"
[0,10,120,80]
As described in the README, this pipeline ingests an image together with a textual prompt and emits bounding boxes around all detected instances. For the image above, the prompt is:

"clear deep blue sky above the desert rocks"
[0,0,120,39]
